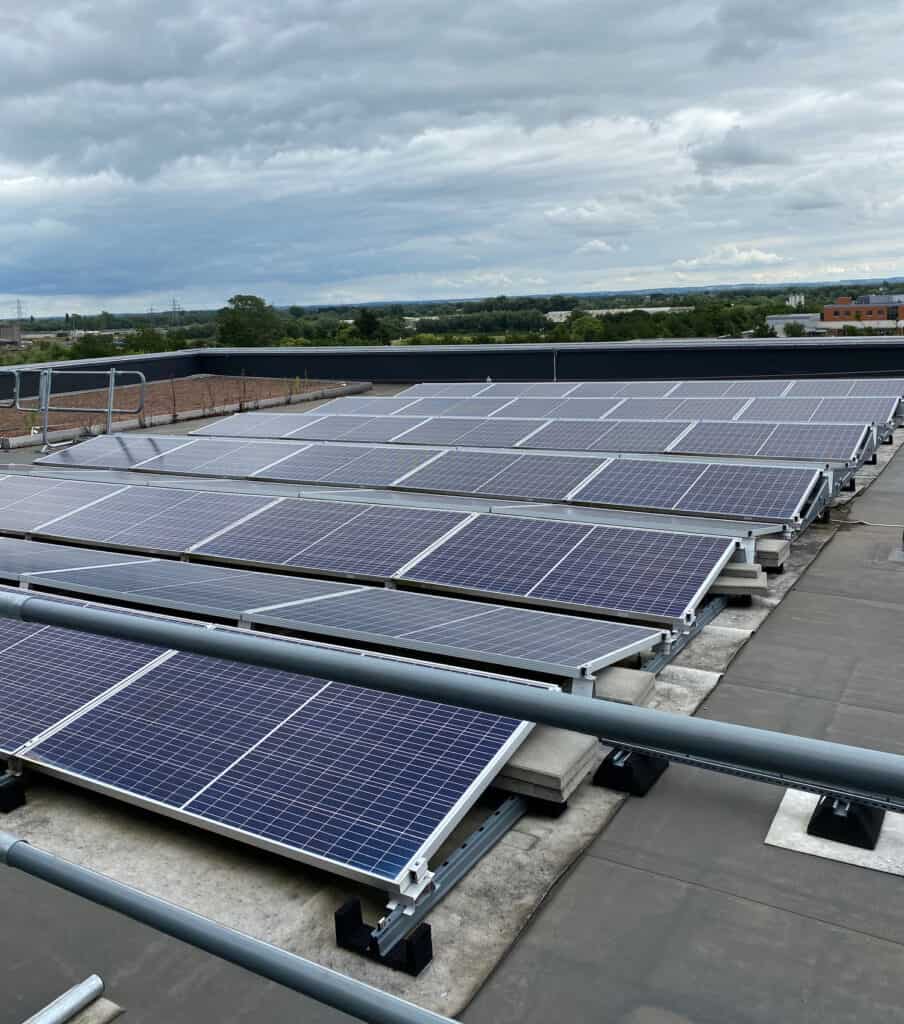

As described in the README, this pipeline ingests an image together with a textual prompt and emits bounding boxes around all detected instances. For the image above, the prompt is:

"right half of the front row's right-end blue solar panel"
[186,683,520,881]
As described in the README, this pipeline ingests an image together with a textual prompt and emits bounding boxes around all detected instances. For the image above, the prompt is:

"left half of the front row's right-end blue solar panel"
[32,653,326,807]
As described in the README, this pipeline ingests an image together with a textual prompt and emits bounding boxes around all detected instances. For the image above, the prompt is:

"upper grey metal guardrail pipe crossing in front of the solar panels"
[0,591,904,811]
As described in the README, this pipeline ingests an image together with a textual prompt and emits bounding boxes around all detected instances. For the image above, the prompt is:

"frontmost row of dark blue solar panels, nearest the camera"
[0,593,529,888]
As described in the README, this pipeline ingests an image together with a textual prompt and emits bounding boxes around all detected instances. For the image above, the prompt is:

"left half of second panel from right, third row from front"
[196,500,370,565]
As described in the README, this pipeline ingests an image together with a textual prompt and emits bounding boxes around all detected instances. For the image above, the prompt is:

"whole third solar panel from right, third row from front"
[35,487,273,552]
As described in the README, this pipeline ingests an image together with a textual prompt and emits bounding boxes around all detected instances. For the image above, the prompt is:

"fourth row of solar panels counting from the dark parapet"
[37,435,820,523]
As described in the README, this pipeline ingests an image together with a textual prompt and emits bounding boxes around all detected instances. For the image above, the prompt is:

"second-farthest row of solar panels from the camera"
[309,395,900,427]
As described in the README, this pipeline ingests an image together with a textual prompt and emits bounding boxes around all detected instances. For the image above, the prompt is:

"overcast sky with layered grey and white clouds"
[0,0,904,315]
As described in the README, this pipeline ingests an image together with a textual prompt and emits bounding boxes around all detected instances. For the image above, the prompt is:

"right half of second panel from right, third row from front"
[283,505,469,579]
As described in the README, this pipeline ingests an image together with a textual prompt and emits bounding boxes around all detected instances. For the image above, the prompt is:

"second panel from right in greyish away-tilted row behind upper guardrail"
[24,561,353,620]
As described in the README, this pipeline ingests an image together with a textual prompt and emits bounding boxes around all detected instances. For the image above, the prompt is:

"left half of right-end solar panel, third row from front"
[404,516,593,594]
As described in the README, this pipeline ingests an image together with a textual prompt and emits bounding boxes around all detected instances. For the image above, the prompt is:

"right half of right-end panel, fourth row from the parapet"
[676,465,819,522]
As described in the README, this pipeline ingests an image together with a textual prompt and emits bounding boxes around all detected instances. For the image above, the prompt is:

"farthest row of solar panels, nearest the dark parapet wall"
[397,377,904,399]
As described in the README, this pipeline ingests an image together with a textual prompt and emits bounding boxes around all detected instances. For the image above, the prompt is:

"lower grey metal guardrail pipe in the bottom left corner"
[0,833,453,1024]
